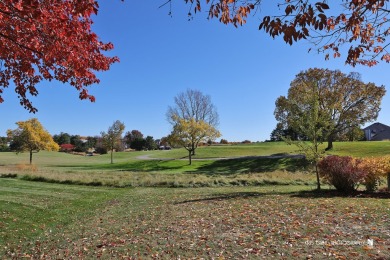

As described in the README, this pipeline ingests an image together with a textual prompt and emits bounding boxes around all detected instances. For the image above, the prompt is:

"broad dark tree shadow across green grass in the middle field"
[193,157,307,175]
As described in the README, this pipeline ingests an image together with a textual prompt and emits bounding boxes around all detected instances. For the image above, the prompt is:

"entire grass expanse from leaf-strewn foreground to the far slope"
[0,142,390,259]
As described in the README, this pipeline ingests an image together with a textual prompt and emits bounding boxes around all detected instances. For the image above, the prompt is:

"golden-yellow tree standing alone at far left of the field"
[7,118,59,164]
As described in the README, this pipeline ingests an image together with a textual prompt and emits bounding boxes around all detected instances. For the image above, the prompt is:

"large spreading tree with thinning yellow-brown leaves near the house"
[274,68,386,150]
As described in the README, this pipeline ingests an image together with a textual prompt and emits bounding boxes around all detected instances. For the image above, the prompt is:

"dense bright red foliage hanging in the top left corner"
[0,0,119,113]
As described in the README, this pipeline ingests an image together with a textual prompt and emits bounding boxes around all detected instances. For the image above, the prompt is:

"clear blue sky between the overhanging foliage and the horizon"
[0,0,390,141]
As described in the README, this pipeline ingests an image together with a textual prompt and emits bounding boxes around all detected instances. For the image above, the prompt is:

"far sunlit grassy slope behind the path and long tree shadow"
[0,141,390,166]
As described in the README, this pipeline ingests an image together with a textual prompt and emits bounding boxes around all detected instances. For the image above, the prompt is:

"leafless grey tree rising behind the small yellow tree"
[166,89,219,155]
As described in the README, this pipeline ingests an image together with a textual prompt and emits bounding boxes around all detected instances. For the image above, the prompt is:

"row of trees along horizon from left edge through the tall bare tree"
[0,89,220,164]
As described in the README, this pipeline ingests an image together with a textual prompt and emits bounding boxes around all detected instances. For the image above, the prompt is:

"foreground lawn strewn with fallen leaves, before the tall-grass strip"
[0,179,390,259]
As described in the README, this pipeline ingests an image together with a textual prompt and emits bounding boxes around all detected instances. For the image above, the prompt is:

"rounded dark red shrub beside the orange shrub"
[318,156,366,192]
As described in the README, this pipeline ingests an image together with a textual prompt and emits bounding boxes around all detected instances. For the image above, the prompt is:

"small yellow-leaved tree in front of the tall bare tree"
[168,117,221,165]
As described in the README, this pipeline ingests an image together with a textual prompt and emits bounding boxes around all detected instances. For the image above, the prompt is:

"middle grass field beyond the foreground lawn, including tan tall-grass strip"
[0,142,390,187]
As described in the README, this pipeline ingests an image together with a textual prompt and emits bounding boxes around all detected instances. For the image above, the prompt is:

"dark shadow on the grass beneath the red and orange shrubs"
[291,190,390,199]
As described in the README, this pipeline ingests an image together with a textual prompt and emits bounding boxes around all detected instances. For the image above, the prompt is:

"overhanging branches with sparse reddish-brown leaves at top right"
[177,0,390,66]
